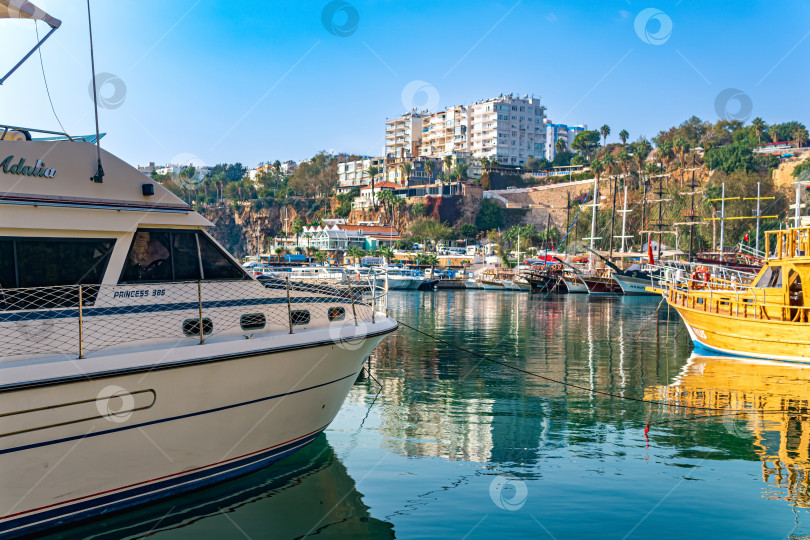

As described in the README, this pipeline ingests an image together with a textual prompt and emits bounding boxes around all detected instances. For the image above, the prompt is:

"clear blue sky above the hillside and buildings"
[0,0,810,166]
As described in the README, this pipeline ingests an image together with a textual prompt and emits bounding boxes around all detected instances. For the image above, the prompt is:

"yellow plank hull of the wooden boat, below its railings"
[667,299,810,363]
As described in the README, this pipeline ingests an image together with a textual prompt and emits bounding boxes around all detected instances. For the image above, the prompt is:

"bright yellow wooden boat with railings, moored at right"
[662,227,810,362]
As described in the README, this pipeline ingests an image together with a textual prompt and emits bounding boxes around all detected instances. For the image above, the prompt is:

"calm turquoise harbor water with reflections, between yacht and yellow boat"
[47,291,810,539]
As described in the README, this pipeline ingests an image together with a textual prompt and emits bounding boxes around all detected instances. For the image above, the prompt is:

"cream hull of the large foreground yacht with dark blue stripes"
[0,322,396,535]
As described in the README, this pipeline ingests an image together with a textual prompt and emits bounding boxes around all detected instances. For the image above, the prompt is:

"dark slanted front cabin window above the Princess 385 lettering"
[119,229,249,283]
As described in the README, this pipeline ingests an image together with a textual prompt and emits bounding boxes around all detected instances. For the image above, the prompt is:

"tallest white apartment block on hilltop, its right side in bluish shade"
[468,94,546,166]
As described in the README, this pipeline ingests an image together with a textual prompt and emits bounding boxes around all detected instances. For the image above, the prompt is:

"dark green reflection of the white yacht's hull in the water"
[46,435,394,540]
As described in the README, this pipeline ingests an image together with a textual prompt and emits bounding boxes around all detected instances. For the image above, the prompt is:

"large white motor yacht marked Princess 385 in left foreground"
[0,6,397,535]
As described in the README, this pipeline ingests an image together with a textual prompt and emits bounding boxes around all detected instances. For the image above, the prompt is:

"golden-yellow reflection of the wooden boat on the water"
[649,355,810,508]
